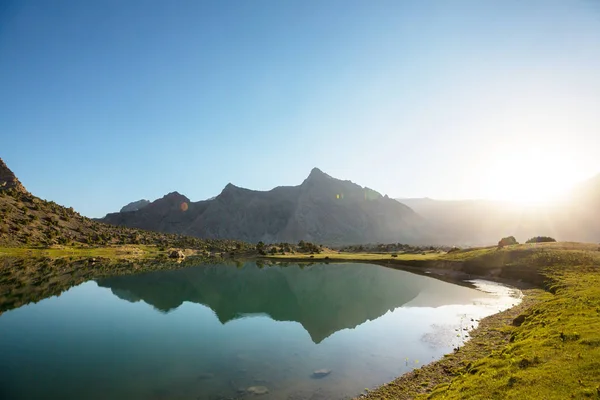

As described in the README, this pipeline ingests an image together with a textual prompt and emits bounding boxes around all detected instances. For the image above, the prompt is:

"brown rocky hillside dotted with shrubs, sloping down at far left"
[0,159,248,251]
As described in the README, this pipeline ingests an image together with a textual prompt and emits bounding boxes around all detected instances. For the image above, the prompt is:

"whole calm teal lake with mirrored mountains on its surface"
[0,263,519,400]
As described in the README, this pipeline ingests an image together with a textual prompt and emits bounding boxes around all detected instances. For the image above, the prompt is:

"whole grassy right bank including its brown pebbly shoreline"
[350,243,600,399]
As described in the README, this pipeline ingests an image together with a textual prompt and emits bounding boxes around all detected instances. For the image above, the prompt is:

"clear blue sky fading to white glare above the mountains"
[0,0,600,217]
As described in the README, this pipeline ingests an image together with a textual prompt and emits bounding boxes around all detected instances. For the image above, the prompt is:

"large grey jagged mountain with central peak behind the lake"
[101,168,423,244]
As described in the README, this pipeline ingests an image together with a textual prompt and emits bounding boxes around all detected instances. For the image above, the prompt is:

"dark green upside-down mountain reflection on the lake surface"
[96,263,485,343]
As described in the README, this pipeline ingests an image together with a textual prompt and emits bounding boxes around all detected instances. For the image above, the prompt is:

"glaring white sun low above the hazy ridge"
[481,149,578,205]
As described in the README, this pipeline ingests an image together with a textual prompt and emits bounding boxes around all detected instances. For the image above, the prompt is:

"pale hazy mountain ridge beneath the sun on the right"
[397,175,600,246]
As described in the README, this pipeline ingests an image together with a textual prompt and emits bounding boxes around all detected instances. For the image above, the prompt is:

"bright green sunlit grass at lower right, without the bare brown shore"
[427,266,600,399]
